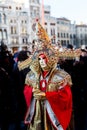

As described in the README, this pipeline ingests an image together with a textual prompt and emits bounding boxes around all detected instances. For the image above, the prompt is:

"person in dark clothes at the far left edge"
[0,43,16,130]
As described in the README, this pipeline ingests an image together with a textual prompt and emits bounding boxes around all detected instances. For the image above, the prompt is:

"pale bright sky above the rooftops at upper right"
[13,0,87,24]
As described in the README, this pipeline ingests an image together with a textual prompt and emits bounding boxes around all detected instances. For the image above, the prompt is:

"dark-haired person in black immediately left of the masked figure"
[13,50,30,130]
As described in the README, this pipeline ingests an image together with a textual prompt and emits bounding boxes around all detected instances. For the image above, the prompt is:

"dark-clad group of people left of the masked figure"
[0,44,29,130]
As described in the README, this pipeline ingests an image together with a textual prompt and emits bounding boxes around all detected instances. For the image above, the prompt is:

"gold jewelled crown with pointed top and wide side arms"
[18,22,81,70]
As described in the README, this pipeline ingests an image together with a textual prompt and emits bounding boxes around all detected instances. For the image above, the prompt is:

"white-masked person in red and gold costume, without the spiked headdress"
[24,45,72,130]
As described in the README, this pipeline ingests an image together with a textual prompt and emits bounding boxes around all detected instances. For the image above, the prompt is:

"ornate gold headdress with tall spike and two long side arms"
[18,22,81,70]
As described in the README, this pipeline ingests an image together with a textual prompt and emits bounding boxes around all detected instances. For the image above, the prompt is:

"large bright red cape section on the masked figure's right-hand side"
[46,85,72,130]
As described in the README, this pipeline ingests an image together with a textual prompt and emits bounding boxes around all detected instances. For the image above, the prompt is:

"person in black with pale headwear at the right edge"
[72,45,87,130]
